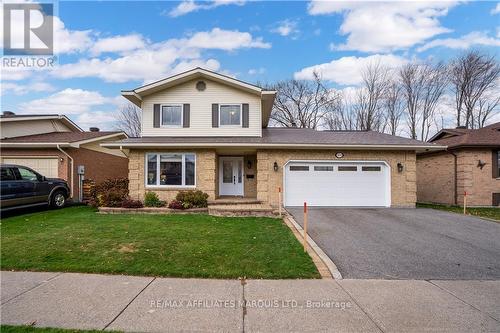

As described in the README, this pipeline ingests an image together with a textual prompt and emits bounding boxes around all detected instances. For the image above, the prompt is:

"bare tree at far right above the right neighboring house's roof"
[450,51,500,128]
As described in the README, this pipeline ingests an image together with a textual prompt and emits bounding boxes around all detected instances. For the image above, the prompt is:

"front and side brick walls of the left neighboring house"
[1,148,128,200]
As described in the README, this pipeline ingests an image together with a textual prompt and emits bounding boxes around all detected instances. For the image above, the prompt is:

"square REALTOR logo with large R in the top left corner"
[3,3,54,55]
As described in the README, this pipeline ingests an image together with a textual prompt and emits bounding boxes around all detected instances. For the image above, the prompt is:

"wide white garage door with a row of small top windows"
[284,161,391,207]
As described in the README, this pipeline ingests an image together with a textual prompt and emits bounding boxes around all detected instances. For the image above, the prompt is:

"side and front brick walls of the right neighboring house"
[417,149,500,206]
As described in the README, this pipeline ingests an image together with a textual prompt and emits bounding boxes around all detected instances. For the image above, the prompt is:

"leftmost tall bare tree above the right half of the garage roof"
[354,62,389,131]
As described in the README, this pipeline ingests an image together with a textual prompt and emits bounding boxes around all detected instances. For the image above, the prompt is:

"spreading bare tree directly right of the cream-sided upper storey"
[271,73,338,129]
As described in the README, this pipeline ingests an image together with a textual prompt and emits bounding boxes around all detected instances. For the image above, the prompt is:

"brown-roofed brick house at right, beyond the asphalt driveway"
[417,123,500,206]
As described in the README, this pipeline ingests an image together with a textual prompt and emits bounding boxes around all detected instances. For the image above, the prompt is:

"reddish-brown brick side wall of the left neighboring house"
[64,148,128,199]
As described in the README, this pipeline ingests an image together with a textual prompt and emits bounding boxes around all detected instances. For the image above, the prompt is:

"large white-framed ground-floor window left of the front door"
[146,153,196,187]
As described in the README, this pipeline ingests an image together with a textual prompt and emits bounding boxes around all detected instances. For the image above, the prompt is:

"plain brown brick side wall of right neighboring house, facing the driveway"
[417,152,455,205]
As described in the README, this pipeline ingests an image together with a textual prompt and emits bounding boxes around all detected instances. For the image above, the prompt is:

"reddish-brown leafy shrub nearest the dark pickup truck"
[89,178,128,207]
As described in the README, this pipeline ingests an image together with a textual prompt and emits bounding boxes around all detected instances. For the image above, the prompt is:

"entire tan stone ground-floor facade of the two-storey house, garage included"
[129,149,417,207]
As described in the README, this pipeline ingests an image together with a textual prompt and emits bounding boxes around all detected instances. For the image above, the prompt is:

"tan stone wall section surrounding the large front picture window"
[129,149,217,201]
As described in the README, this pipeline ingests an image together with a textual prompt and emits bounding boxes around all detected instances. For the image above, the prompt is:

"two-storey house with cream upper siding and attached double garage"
[102,68,443,207]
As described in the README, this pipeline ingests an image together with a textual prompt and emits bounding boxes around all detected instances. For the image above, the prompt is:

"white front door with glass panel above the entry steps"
[219,157,243,196]
